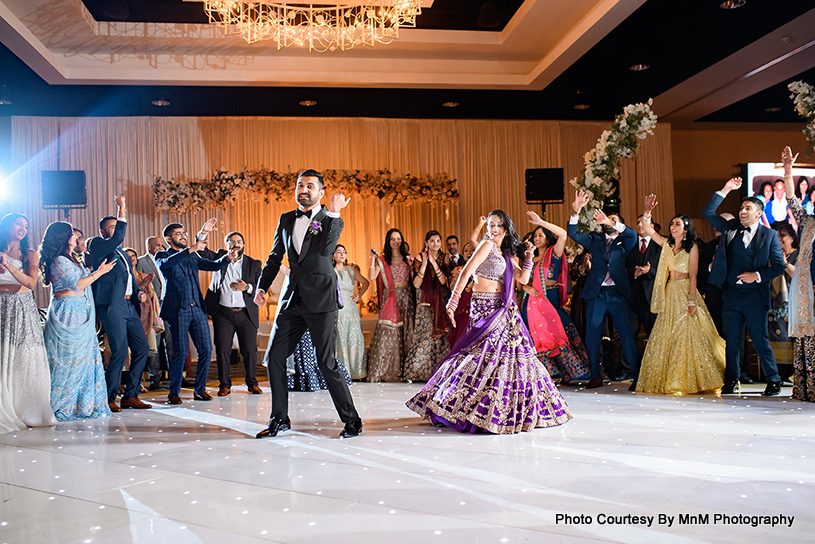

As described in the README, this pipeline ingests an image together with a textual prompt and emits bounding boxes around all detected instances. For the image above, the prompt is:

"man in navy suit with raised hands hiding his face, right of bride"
[566,191,640,391]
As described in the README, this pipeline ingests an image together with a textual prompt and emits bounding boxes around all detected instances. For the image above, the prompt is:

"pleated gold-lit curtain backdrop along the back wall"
[3,117,674,307]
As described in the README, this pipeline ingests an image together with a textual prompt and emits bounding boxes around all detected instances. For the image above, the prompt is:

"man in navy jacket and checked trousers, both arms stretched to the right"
[156,219,238,404]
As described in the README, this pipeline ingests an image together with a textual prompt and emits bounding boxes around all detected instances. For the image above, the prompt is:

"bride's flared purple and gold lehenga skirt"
[406,292,572,434]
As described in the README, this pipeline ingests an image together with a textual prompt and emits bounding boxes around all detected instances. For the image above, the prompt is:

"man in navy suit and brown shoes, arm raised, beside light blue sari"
[87,196,151,412]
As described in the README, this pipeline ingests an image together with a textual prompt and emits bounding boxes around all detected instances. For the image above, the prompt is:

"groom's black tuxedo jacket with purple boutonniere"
[258,206,343,313]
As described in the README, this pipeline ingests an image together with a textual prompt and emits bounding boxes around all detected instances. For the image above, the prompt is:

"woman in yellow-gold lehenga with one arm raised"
[636,195,725,395]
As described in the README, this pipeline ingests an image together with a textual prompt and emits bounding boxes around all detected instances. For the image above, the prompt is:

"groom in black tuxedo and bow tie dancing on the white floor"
[255,170,362,438]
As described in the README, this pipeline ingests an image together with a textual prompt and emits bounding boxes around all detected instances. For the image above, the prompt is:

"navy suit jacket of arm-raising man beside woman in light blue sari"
[87,221,141,313]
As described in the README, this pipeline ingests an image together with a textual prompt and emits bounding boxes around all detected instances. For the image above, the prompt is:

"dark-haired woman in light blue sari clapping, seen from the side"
[40,221,115,421]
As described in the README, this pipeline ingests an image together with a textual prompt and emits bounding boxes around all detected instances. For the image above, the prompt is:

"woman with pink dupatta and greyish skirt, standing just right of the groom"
[368,229,415,382]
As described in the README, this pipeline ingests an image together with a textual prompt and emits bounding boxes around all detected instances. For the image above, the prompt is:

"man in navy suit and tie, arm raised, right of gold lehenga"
[702,178,784,396]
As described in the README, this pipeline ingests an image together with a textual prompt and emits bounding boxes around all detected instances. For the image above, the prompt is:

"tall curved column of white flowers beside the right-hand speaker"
[569,100,657,233]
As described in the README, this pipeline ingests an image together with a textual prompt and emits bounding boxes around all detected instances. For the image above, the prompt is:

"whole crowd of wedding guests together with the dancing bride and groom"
[0,147,815,438]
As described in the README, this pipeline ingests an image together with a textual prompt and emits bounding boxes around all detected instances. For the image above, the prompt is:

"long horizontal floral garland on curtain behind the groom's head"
[152,168,459,214]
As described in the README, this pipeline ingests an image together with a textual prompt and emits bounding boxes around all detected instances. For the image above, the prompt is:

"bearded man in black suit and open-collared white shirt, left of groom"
[204,232,263,397]
